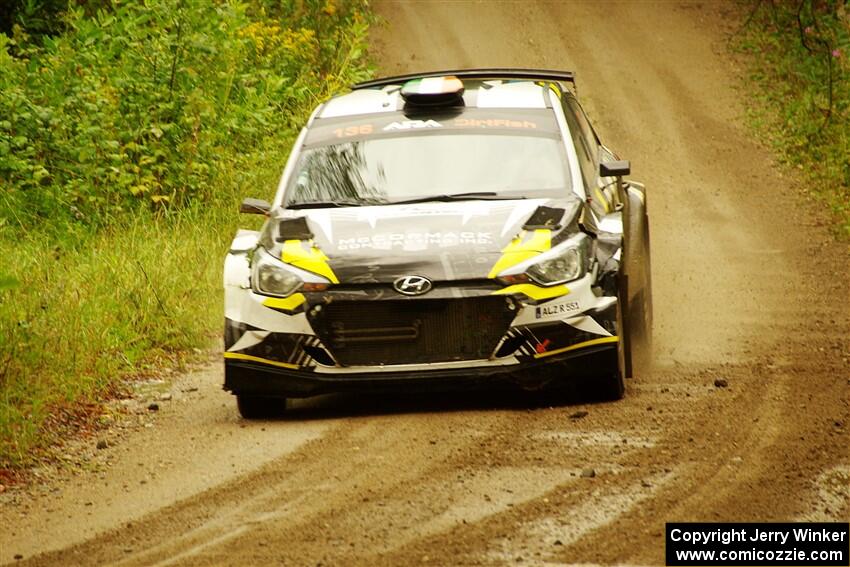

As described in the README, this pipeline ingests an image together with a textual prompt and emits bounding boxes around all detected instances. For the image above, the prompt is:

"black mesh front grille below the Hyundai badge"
[310,297,515,366]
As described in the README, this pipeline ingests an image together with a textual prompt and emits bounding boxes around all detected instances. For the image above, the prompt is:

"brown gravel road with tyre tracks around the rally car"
[0,2,850,565]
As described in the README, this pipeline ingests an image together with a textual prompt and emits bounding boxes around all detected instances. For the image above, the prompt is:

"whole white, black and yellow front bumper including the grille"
[224,244,620,397]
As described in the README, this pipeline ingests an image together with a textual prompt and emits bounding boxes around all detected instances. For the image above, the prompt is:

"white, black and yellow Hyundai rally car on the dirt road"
[224,69,652,418]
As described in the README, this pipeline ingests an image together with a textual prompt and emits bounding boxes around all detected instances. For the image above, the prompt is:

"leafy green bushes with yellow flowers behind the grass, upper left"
[0,0,372,232]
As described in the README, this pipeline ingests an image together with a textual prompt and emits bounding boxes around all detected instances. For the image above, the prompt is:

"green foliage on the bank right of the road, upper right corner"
[738,0,850,236]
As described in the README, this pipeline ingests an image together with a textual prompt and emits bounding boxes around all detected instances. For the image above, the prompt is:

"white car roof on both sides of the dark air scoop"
[317,69,575,118]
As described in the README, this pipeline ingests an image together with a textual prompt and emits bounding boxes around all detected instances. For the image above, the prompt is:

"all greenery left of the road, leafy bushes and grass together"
[0,0,369,469]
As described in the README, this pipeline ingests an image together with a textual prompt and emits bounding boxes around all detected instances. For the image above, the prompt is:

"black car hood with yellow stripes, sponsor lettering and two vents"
[263,197,584,283]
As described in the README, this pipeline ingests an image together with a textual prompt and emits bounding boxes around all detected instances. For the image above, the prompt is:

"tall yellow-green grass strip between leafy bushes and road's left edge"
[0,213,222,463]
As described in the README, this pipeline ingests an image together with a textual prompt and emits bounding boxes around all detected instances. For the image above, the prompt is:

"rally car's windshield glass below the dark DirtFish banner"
[286,132,571,206]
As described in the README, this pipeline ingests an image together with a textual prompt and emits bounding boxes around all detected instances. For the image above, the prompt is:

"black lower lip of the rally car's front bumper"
[224,341,617,398]
